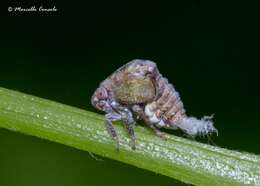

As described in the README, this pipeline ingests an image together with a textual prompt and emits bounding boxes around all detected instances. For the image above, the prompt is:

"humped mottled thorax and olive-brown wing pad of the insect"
[97,60,156,104]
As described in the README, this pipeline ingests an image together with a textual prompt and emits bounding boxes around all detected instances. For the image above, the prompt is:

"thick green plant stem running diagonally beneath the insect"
[0,88,260,186]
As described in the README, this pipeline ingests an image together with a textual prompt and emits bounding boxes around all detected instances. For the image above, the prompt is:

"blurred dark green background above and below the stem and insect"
[0,1,260,186]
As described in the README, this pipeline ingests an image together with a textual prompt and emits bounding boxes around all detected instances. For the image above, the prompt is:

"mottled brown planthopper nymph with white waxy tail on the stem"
[91,59,217,149]
